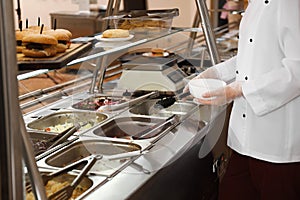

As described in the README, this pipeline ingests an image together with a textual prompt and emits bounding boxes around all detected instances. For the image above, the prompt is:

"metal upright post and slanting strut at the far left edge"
[0,1,46,199]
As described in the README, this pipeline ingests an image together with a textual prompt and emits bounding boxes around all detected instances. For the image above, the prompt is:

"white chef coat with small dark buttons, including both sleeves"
[214,0,300,163]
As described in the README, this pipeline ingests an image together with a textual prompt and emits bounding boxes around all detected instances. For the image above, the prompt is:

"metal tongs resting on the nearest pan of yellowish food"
[26,155,102,200]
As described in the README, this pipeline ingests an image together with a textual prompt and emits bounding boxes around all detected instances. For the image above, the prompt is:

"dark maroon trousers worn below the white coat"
[219,151,300,200]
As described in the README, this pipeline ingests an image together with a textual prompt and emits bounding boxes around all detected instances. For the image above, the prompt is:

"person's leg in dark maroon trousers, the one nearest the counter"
[219,151,259,200]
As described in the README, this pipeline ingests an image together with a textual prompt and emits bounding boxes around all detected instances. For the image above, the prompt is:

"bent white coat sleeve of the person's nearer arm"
[242,0,300,116]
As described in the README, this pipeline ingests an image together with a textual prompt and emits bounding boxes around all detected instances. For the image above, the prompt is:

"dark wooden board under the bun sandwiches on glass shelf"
[17,42,92,70]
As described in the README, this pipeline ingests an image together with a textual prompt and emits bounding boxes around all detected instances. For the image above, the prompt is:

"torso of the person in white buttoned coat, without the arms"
[228,0,300,162]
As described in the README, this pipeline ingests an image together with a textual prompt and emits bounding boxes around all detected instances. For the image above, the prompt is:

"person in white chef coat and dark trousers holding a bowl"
[189,0,300,200]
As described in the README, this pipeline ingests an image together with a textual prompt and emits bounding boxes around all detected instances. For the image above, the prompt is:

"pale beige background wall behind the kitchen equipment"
[14,0,196,28]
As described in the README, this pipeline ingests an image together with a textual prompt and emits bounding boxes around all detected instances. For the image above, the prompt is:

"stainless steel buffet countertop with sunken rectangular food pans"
[24,86,226,199]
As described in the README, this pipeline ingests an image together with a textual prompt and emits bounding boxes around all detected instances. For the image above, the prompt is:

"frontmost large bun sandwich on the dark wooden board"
[22,34,58,58]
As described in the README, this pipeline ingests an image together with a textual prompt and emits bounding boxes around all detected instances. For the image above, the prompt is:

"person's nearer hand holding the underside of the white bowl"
[195,81,243,106]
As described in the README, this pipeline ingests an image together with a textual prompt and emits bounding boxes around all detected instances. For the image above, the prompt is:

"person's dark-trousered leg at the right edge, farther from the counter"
[250,159,300,200]
